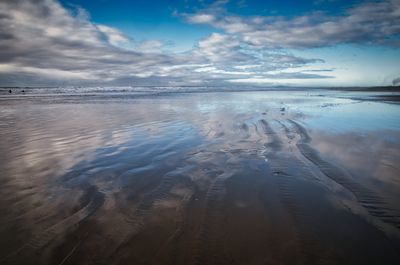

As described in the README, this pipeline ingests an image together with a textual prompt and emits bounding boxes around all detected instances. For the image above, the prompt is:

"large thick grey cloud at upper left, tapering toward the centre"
[0,0,186,81]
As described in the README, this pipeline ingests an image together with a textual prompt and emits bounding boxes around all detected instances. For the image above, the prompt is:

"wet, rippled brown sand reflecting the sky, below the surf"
[0,92,400,265]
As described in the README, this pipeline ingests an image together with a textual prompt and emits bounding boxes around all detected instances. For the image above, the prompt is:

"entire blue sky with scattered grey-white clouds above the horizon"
[0,0,400,87]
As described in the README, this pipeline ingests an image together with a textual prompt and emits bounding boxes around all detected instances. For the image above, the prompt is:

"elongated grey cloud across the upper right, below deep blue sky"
[184,0,400,48]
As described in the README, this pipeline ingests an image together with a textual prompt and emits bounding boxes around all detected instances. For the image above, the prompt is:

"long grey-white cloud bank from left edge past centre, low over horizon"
[0,0,327,85]
